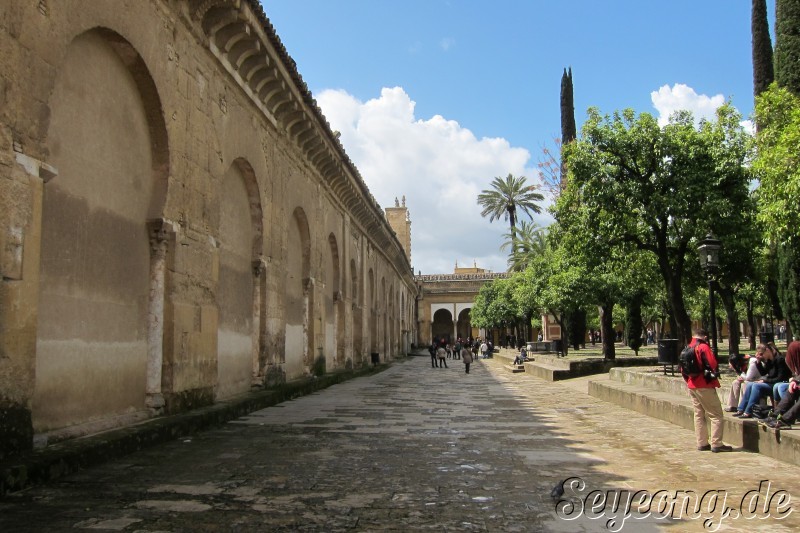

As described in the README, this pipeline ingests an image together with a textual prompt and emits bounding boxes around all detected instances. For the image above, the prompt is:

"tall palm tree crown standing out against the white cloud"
[478,174,544,240]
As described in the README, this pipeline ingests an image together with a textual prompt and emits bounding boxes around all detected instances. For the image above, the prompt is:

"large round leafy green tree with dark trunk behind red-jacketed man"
[556,105,751,338]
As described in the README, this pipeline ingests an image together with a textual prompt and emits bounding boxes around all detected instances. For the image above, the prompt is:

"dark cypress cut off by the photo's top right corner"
[775,0,800,96]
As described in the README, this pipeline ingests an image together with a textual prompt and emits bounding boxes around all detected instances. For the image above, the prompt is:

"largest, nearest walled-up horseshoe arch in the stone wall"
[32,29,169,432]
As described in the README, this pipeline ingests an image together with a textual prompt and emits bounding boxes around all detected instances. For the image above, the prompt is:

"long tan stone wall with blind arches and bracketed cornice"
[0,0,416,457]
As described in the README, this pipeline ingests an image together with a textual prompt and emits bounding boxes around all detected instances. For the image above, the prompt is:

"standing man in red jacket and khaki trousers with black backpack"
[683,329,733,453]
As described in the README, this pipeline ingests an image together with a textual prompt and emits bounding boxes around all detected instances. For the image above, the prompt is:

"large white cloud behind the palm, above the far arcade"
[317,87,548,274]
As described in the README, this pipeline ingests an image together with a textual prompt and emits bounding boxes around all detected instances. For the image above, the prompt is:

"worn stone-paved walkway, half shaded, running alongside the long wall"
[0,357,800,532]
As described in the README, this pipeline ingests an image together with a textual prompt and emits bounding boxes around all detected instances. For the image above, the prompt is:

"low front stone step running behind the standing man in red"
[588,375,800,465]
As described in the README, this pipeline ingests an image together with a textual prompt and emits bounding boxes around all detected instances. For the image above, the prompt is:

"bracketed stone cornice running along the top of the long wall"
[189,0,412,280]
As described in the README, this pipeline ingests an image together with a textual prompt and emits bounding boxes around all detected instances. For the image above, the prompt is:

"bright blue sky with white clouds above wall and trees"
[262,0,775,274]
